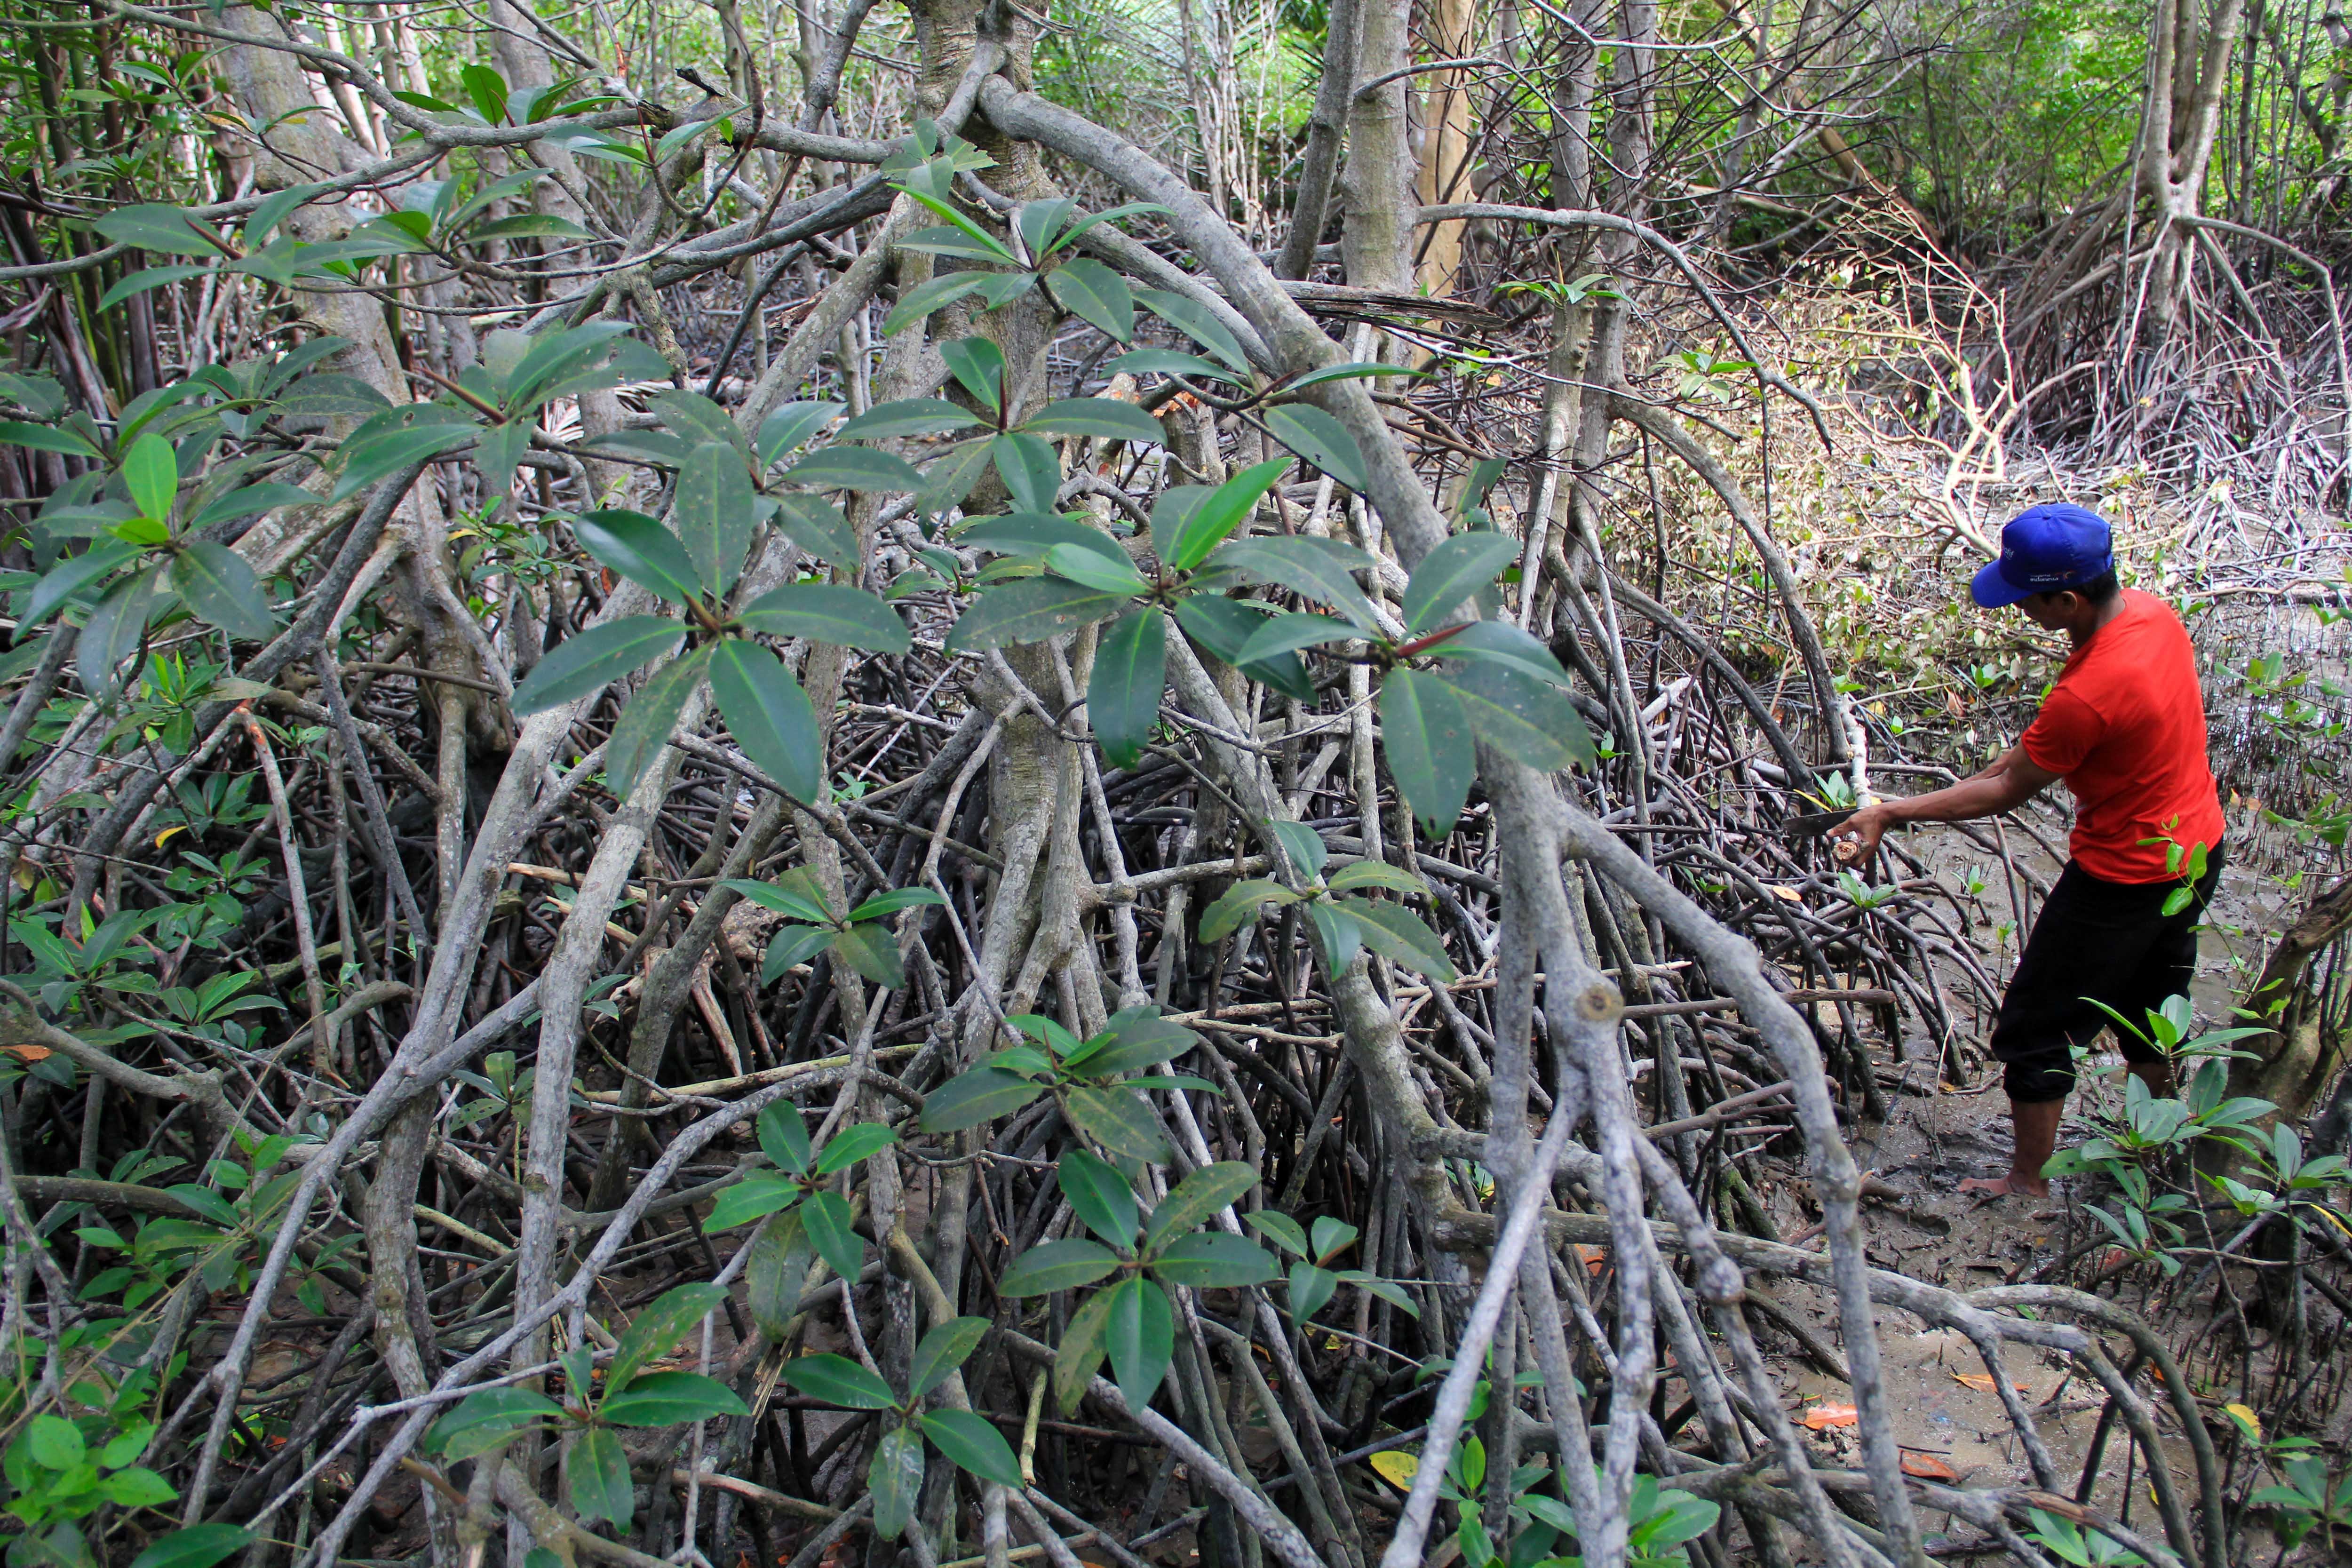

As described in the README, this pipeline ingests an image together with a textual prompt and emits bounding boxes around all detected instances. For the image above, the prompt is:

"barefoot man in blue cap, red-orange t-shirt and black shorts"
[1837,503,2223,1196]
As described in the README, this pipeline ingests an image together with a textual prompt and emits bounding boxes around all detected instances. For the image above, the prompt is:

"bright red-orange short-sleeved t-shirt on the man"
[2020,588,2223,882]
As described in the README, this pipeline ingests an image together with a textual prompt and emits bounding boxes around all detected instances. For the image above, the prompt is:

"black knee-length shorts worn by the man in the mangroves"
[1992,844,2223,1105]
